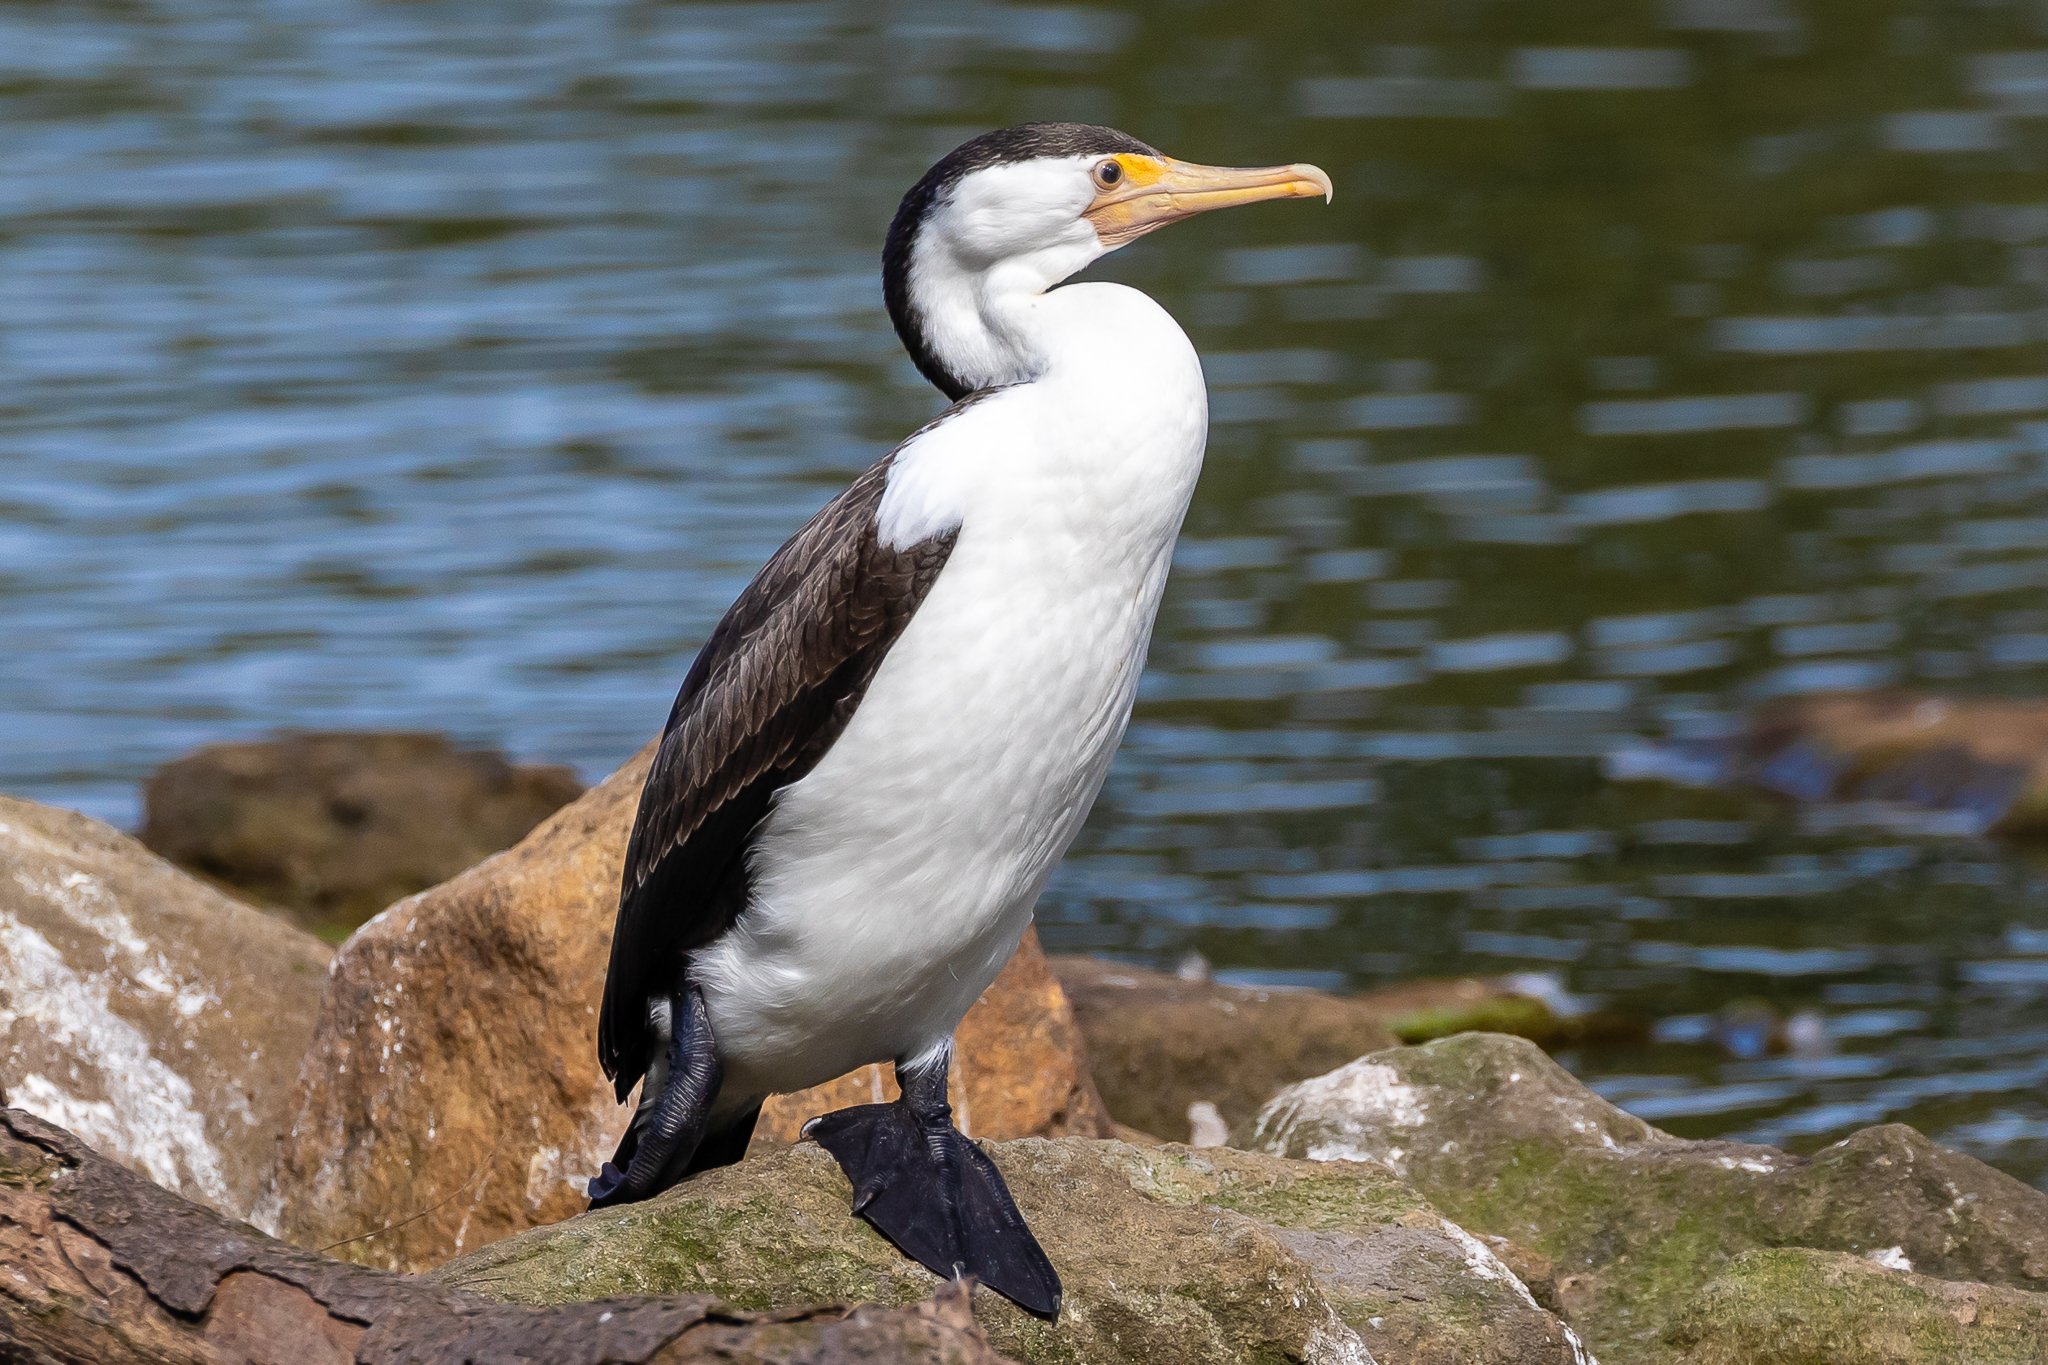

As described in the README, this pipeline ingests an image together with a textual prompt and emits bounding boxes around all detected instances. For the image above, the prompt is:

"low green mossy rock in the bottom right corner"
[1665,1248,2048,1365]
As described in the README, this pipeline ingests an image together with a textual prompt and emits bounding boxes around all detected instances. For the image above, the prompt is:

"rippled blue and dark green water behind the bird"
[0,0,2048,1181]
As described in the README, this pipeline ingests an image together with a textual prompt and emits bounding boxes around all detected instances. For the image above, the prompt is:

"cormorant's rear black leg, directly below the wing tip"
[590,986,725,1209]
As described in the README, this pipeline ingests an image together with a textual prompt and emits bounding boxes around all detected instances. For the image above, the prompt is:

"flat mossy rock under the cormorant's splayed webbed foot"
[436,1138,1575,1365]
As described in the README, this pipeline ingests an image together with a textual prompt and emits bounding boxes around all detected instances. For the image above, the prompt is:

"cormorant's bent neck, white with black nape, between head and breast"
[891,232,1100,399]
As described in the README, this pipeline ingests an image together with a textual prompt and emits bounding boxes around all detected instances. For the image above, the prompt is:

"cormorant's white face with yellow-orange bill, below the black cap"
[920,151,1331,289]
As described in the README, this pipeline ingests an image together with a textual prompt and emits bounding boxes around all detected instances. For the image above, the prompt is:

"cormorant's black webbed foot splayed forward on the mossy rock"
[803,1048,1061,1318]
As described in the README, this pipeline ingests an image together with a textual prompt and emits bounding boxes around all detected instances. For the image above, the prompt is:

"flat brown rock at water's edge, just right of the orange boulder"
[1051,958,1397,1138]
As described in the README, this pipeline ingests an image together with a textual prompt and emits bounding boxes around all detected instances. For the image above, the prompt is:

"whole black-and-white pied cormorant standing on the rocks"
[590,123,1331,1316]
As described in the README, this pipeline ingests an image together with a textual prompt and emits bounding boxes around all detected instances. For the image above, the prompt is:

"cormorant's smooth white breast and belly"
[692,284,1208,1099]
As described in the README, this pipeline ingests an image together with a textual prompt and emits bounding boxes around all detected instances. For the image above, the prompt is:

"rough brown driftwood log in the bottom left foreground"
[0,1109,1004,1365]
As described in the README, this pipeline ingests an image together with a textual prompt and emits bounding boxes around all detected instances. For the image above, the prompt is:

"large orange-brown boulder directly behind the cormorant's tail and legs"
[272,745,1122,1271]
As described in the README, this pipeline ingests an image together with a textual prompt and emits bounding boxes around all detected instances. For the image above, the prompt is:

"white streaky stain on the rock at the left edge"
[0,911,227,1207]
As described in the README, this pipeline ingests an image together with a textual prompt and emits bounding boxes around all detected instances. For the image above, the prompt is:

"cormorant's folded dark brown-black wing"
[598,454,956,1099]
